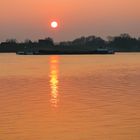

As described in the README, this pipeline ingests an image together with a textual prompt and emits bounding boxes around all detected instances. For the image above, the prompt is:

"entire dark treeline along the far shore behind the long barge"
[0,34,140,52]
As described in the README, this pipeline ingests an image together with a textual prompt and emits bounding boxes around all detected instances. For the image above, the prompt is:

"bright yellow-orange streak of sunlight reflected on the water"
[50,56,59,107]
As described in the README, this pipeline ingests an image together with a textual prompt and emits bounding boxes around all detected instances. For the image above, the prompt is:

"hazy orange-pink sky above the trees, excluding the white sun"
[0,0,140,41]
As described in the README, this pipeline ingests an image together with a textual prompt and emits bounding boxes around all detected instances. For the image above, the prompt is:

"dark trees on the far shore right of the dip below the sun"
[60,34,140,52]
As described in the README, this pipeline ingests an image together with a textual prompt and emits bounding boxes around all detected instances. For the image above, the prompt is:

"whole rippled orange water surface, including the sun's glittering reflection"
[0,53,140,140]
